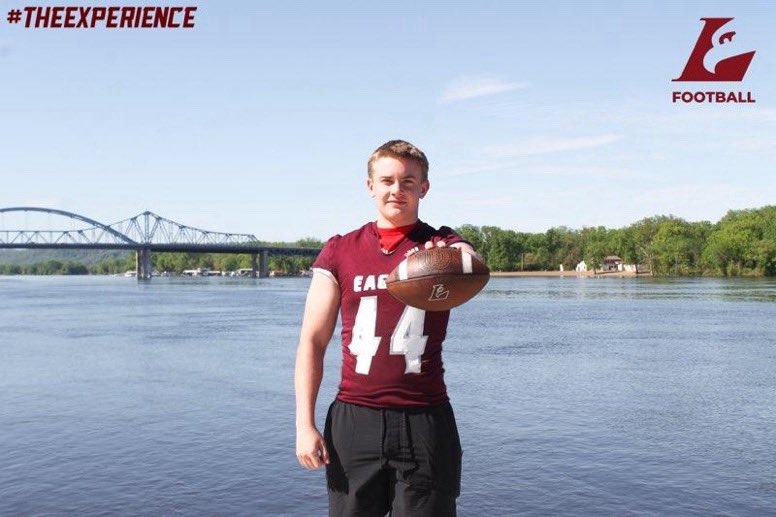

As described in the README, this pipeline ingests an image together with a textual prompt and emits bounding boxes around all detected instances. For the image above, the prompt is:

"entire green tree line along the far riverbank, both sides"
[0,206,776,276]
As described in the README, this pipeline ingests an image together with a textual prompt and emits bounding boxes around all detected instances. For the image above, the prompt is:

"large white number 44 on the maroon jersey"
[348,296,428,375]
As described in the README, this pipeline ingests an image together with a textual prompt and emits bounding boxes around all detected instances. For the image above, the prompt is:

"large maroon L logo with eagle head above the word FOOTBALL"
[674,18,755,81]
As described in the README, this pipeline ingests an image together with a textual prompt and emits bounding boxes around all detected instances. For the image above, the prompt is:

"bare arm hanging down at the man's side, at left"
[294,272,339,469]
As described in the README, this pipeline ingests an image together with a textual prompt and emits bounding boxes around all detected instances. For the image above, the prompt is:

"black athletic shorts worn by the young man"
[324,401,461,517]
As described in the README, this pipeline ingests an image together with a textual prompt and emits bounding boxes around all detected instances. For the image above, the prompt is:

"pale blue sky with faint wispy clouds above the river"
[0,0,776,240]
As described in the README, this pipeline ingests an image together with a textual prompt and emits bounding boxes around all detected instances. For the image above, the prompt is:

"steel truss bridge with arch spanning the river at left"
[0,206,320,279]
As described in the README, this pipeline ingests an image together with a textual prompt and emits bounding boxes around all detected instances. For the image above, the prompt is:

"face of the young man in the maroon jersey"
[366,156,430,228]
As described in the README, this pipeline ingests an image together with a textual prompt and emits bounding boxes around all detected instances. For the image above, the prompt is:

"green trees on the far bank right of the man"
[457,206,776,276]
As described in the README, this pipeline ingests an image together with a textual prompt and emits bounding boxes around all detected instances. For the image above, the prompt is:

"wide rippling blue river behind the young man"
[0,277,776,516]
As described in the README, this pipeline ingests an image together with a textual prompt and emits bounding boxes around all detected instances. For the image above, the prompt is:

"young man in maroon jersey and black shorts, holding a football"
[295,140,474,517]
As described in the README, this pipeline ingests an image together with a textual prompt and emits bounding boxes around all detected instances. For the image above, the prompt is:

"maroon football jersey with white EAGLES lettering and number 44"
[313,221,462,407]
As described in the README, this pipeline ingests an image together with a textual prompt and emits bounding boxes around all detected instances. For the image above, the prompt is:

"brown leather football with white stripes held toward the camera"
[385,247,490,311]
